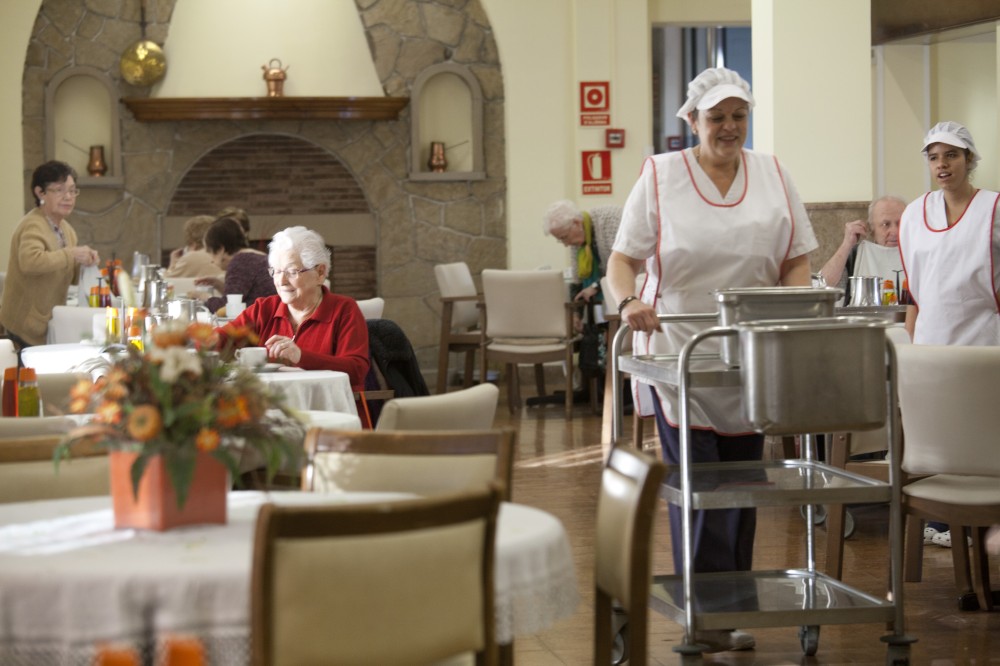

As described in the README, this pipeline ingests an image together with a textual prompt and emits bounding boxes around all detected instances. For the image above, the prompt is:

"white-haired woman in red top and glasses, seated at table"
[220,227,369,390]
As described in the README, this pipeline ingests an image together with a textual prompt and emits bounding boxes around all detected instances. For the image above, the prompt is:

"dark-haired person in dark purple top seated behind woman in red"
[194,217,278,314]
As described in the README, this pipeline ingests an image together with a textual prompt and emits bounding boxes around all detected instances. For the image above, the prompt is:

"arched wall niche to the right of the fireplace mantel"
[410,62,486,180]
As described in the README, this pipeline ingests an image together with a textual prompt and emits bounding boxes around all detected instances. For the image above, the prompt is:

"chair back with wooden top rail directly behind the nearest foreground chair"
[302,428,516,502]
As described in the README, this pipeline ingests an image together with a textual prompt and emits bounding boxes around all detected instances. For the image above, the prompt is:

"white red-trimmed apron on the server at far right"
[899,190,1000,346]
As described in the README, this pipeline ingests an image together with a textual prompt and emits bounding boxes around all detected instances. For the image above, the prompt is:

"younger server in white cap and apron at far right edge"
[899,121,1000,345]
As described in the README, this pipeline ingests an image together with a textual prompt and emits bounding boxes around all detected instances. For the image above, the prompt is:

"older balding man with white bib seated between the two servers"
[820,196,906,303]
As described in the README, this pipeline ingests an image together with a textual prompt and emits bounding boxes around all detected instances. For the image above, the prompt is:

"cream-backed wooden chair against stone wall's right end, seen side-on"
[434,261,486,393]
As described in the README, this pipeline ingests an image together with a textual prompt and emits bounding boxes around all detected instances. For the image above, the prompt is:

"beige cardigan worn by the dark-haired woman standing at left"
[0,208,78,345]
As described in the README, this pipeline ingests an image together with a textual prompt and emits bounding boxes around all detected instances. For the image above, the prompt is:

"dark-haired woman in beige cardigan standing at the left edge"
[0,161,100,349]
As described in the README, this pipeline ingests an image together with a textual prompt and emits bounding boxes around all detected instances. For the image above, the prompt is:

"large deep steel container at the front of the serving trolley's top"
[736,317,888,435]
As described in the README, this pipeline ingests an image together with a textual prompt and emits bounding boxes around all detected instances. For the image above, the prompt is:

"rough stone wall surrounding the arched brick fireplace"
[22,0,507,370]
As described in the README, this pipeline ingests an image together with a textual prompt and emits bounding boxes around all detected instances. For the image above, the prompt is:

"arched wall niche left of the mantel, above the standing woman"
[45,66,124,187]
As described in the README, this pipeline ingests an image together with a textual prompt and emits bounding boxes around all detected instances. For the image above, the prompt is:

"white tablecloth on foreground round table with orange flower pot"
[0,492,578,666]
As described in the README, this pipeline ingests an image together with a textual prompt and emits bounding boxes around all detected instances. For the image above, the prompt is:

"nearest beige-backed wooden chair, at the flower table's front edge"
[250,485,500,666]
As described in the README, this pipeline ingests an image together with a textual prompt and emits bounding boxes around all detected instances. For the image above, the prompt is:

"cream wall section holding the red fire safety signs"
[482,0,652,269]
